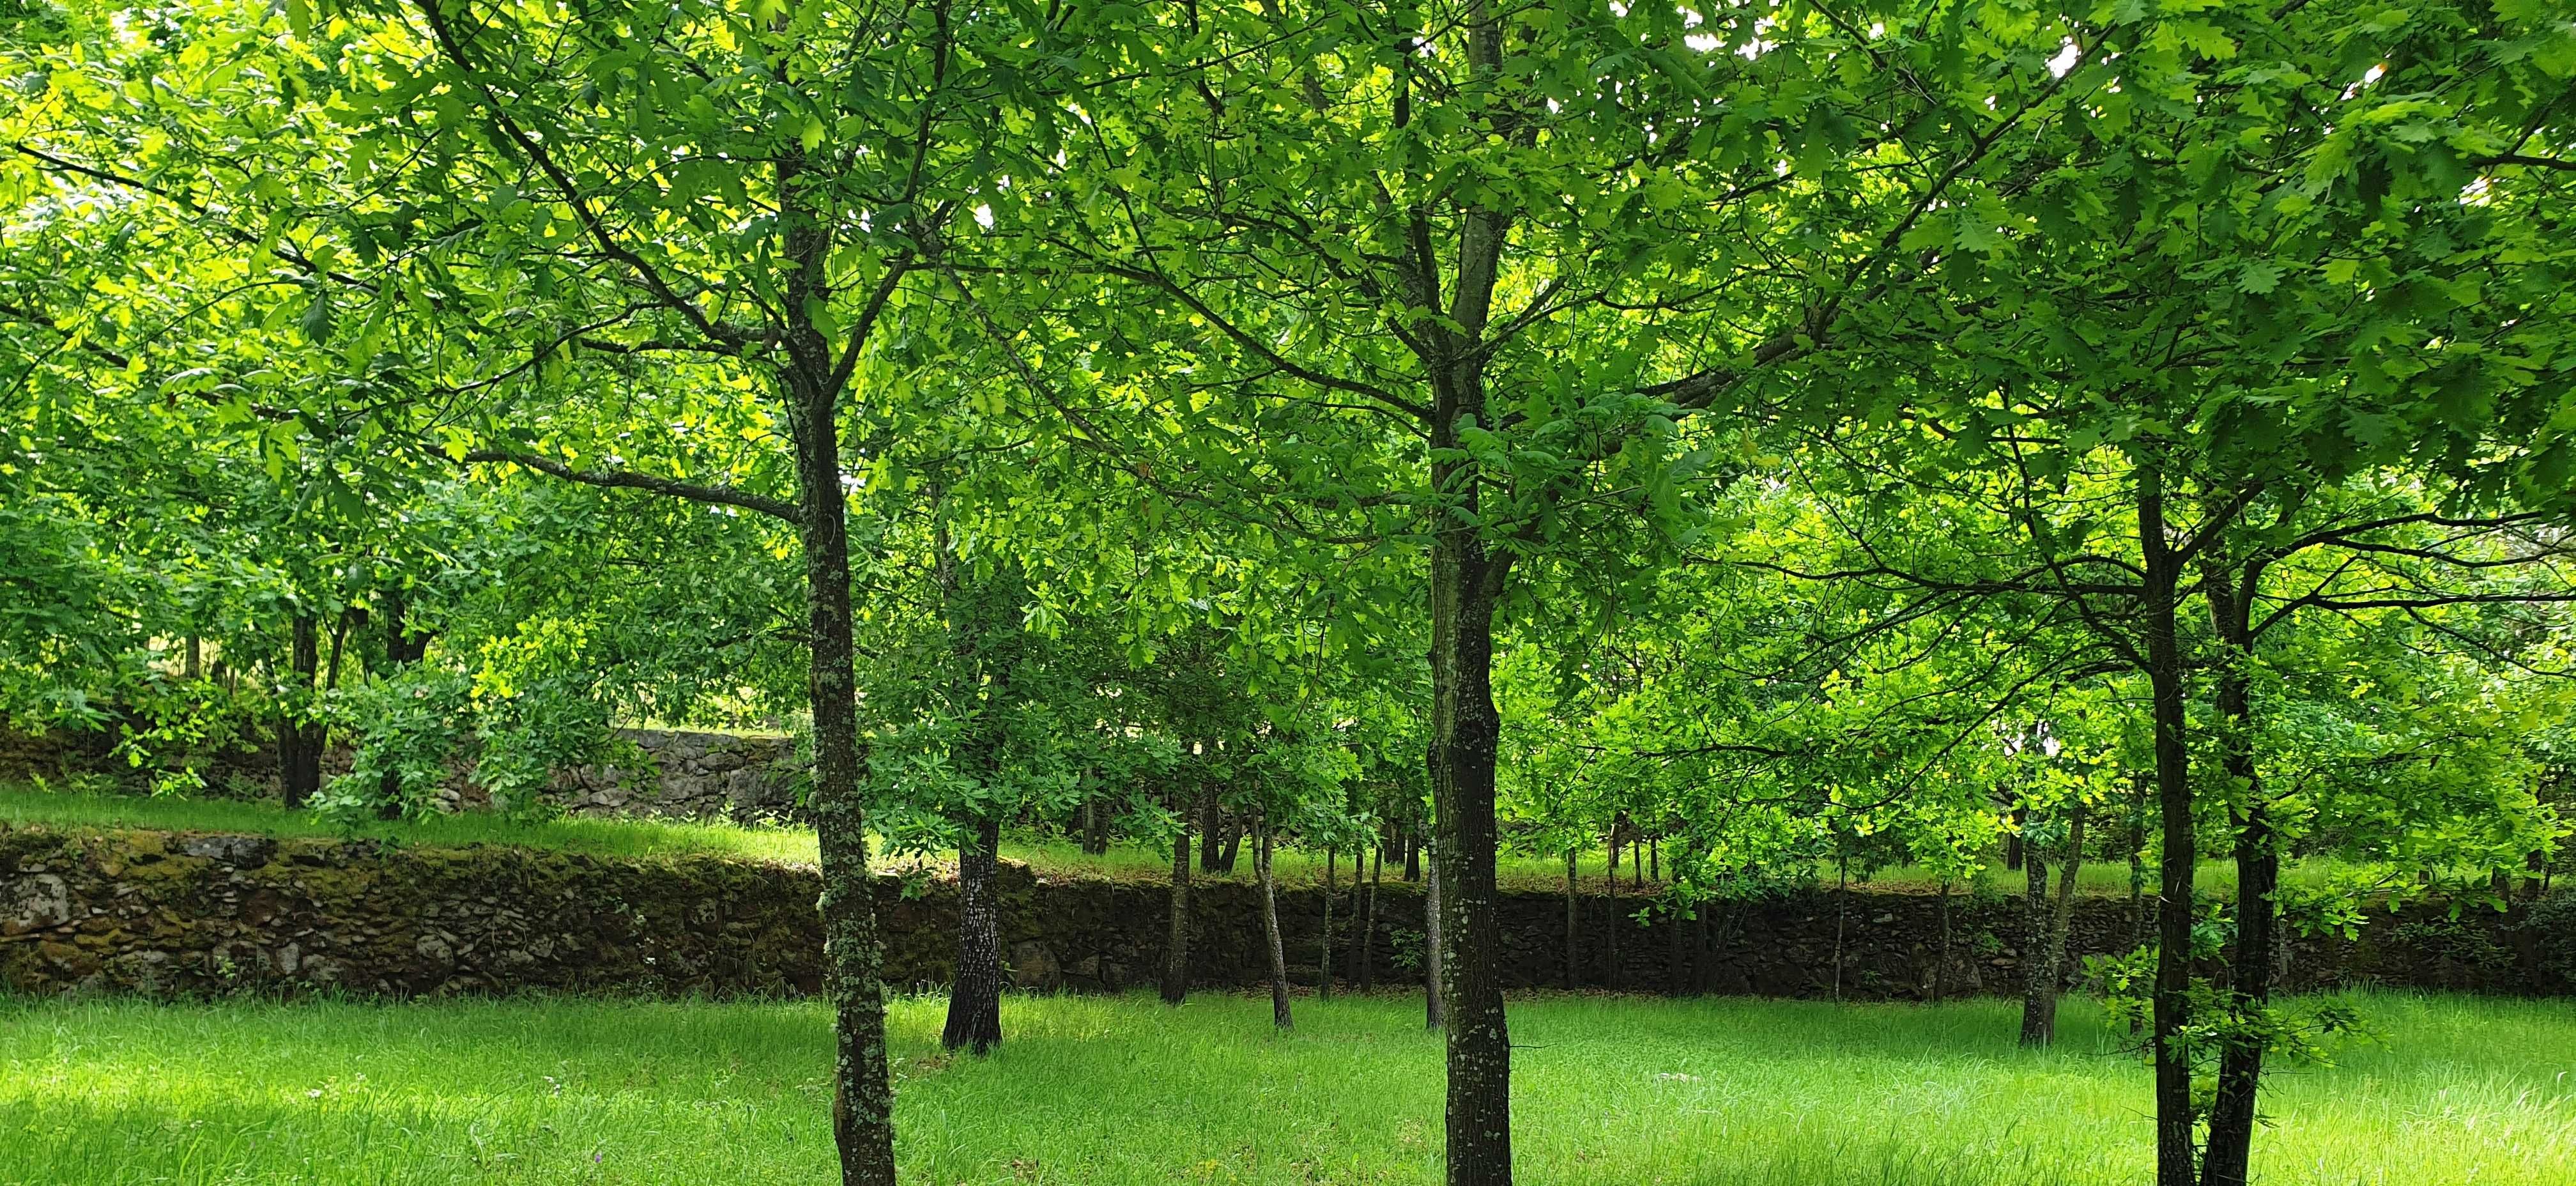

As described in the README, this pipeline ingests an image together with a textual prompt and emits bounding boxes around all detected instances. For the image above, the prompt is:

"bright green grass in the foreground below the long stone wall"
[0,995,2576,1186]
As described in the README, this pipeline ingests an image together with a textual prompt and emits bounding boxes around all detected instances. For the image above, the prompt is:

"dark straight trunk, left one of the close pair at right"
[2138,466,2197,1186]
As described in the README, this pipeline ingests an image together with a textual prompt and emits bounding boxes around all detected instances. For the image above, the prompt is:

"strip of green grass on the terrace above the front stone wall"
[0,784,2334,892]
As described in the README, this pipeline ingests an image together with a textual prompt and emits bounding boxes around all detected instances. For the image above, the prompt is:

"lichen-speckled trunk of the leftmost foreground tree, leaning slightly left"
[788,387,894,1186]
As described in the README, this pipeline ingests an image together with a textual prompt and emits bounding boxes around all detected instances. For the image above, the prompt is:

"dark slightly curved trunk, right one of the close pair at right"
[2200,560,2280,1186]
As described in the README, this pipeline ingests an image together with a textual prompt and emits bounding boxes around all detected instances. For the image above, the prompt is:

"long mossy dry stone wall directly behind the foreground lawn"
[0,828,2576,1000]
